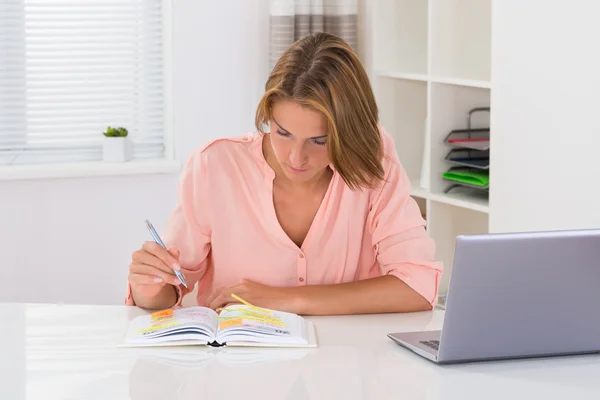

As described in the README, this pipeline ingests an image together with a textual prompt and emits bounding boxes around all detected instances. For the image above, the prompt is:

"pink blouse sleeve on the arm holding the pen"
[125,150,211,306]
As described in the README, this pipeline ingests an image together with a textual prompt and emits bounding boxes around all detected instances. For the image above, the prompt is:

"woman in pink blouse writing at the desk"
[125,33,442,315]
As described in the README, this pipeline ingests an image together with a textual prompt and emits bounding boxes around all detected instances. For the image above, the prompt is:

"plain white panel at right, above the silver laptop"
[490,0,600,231]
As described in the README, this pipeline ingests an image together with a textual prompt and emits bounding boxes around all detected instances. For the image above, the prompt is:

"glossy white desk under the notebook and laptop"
[0,304,600,400]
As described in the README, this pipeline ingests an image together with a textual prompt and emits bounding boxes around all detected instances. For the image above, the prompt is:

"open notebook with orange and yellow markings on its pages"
[121,304,317,347]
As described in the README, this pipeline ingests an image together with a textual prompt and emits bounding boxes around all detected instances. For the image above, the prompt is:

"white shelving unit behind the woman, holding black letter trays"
[368,0,494,295]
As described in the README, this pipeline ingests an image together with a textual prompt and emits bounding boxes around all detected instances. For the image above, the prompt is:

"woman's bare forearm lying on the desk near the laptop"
[289,275,432,315]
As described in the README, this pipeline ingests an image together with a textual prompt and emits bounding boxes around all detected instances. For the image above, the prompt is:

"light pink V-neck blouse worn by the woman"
[125,126,443,306]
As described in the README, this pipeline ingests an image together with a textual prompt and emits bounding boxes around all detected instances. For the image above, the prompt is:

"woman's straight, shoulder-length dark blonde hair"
[255,33,384,189]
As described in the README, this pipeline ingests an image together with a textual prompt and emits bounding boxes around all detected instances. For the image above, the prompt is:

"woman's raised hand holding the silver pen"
[128,241,181,297]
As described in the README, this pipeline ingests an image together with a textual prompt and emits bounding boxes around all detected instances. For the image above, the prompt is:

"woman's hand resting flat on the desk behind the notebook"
[206,279,295,312]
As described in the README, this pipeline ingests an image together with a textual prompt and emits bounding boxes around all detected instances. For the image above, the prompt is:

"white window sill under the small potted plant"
[0,159,181,181]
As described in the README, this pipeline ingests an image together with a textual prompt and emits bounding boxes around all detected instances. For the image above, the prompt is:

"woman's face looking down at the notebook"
[270,101,330,183]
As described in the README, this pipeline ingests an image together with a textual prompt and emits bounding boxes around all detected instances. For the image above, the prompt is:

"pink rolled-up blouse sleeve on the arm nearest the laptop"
[369,139,443,305]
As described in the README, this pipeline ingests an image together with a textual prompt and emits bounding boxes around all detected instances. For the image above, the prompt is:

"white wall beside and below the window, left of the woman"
[0,0,269,304]
